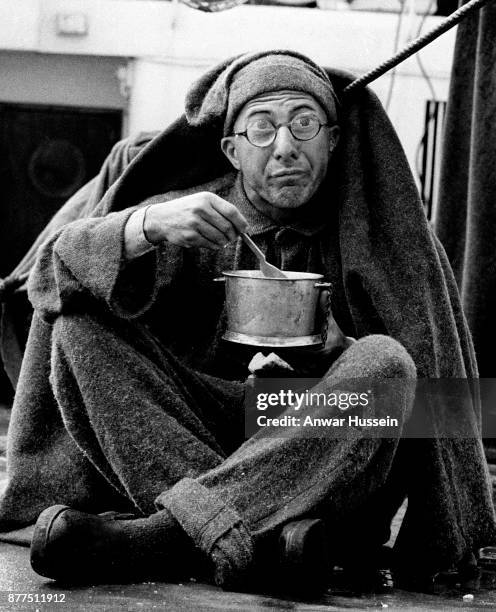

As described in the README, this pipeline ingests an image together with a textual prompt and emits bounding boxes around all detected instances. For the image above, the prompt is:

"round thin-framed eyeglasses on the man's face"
[234,114,329,147]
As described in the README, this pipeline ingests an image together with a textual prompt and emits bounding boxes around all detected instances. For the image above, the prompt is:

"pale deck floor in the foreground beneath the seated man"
[0,408,496,612]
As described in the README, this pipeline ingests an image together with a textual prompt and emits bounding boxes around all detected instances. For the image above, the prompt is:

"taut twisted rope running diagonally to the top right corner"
[343,0,492,95]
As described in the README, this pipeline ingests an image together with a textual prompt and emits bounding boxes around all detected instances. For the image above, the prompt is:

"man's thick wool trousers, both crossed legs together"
[52,316,415,584]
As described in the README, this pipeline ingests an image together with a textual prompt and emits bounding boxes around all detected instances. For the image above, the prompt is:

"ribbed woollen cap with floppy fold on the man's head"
[185,50,338,135]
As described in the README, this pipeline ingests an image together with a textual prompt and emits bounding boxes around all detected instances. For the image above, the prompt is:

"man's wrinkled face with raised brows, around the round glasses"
[222,91,339,220]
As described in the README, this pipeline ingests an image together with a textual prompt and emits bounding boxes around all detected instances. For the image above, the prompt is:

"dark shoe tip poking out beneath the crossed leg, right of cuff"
[279,519,332,597]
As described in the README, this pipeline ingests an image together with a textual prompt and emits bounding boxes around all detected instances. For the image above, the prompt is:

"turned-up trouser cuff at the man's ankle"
[155,478,254,588]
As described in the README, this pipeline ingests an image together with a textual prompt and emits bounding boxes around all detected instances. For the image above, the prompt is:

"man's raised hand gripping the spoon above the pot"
[144,191,248,249]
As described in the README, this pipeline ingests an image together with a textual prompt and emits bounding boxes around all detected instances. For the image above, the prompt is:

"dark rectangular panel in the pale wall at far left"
[0,104,122,402]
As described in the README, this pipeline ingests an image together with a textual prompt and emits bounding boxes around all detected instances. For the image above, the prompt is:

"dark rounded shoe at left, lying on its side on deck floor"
[31,505,196,584]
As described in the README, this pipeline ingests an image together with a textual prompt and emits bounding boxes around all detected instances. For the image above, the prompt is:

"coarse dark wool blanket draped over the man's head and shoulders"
[0,70,496,571]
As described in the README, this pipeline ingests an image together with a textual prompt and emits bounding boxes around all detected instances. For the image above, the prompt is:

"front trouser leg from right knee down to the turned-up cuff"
[157,336,416,584]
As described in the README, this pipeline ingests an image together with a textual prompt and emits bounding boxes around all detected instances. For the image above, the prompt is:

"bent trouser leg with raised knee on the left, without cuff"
[51,308,244,513]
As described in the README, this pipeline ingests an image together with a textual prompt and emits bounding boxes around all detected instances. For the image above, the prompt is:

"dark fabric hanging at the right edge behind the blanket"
[434,3,496,382]
